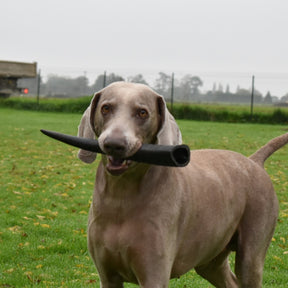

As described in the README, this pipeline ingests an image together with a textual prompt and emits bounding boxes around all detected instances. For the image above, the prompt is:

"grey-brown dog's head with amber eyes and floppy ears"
[78,82,182,175]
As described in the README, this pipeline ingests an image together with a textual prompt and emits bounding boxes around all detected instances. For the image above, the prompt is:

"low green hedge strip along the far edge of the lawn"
[0,96,288,124]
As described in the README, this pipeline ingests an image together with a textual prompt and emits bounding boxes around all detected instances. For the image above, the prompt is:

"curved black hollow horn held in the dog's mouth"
[41,129,190,167]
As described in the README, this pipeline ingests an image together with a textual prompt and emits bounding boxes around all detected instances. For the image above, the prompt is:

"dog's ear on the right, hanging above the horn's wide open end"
[157,95,182,145]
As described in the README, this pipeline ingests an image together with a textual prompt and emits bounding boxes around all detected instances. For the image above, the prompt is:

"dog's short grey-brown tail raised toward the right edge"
[249,133,288,167]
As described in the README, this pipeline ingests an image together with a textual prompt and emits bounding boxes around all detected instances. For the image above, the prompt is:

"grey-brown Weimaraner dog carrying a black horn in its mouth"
[78,82,288,288]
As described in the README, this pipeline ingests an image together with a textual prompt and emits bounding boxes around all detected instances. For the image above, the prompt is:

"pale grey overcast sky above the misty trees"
[0,0,288,96]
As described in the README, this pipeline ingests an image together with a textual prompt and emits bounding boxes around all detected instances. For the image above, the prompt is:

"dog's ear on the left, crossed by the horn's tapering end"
[78,93,100,164]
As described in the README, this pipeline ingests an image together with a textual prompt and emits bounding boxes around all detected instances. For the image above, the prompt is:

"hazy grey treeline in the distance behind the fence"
[18,72,288,104]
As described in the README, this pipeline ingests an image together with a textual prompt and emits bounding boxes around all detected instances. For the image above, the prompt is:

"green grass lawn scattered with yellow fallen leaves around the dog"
[0,109,288,288]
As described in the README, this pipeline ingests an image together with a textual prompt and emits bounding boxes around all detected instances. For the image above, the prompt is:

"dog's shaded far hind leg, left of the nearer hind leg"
[195,249,238,288]
